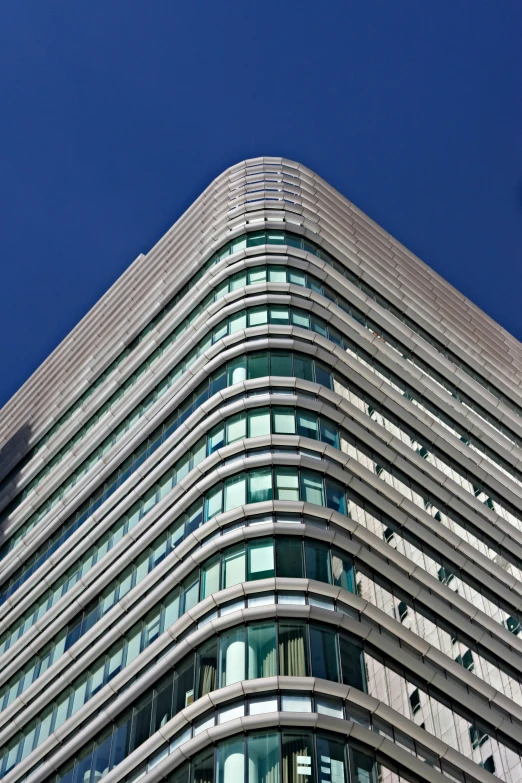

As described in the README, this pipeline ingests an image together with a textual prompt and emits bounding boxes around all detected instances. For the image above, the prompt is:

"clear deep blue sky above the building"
[0,0,522,404]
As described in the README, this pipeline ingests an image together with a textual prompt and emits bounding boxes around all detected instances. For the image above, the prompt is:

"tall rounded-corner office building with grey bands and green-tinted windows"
[0,158,522,783]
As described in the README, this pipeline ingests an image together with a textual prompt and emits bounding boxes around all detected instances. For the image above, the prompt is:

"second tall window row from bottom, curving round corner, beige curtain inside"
[7,619,520,781]
